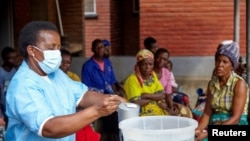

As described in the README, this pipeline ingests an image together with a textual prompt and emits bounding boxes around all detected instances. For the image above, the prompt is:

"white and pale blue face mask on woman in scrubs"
[33,46,62,74]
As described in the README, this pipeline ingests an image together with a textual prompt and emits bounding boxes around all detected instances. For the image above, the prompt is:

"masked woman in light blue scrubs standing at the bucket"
[5,21,125,141]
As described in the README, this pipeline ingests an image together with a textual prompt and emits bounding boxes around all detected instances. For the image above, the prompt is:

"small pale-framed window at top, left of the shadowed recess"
[84,0,97,18]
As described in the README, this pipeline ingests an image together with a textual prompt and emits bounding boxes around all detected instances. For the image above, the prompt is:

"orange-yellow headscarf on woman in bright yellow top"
[135,49,154,87]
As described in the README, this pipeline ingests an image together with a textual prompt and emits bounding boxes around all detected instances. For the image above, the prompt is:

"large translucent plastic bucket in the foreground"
[119,116,198,141]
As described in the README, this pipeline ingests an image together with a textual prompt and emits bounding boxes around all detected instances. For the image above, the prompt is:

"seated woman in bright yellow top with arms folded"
[124,49,166,116]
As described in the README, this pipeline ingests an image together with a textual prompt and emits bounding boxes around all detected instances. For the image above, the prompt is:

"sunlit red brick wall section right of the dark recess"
[139,0,246,56]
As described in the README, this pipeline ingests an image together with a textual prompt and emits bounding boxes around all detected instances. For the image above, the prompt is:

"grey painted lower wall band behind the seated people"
[71,56,214,81]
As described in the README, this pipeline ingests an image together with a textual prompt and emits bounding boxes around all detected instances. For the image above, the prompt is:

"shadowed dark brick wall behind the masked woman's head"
[13,0,85,54]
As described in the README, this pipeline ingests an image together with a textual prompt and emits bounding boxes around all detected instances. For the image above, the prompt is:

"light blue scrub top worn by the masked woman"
[5,61,88,141]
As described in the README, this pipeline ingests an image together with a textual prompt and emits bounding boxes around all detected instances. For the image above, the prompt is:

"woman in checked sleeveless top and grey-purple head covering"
[196,41,249,141]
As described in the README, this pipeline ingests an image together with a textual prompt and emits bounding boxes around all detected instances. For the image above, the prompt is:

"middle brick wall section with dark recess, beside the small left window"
[84,0,139,57]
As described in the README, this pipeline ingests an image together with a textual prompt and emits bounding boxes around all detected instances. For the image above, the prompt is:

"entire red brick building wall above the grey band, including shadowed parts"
[13,0,249,57]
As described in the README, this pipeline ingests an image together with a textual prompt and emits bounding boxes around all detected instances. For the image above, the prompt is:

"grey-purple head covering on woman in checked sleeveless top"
[215,40,239,69]
